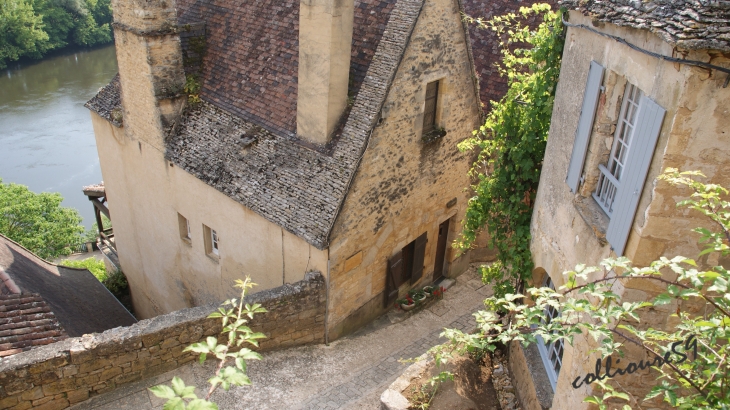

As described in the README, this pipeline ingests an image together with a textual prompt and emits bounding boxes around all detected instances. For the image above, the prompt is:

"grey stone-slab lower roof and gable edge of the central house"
[166,0,422,249]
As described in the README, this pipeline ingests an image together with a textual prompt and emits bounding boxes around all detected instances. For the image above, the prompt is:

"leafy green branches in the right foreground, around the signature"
[440,169,730,409]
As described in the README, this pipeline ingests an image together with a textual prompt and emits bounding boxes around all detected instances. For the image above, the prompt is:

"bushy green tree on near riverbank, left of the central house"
[0,179,84,259]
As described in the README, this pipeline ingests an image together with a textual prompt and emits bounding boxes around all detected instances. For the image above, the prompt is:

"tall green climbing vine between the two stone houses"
[454,4,564,296]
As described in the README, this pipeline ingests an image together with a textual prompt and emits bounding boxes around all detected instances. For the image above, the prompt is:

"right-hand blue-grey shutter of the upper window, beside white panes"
[606,96,666,256]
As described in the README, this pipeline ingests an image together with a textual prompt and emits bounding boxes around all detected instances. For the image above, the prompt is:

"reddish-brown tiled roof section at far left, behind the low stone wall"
[0,293,68,357]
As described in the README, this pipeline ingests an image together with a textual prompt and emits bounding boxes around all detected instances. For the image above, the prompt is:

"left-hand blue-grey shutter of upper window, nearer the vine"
[565,61,604,192]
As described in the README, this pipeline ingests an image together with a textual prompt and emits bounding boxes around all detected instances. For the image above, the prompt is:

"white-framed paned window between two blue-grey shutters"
[593,84,642,217]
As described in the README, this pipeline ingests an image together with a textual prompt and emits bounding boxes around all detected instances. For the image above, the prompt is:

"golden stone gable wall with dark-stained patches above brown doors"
[328,0,480,338]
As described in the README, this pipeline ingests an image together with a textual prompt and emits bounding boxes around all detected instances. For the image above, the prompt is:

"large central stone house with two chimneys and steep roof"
[87,0,548,339]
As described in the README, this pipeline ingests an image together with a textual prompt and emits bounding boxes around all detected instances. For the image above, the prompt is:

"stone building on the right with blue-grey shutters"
[512,0,730,409]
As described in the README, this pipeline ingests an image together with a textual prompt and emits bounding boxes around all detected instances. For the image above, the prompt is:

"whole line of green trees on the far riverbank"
[0,0,112,69]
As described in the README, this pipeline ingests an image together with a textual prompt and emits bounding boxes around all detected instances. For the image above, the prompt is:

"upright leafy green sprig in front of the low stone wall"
[150,276,266,410]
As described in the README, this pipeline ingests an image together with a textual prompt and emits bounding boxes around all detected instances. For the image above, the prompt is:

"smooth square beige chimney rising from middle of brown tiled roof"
[297,0,355,144]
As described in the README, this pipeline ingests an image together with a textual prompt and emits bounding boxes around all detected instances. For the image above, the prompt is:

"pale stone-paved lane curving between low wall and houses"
[73,268,490,410]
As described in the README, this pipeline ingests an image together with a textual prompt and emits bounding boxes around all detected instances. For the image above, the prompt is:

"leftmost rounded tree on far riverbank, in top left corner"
[0,0,49,69]
